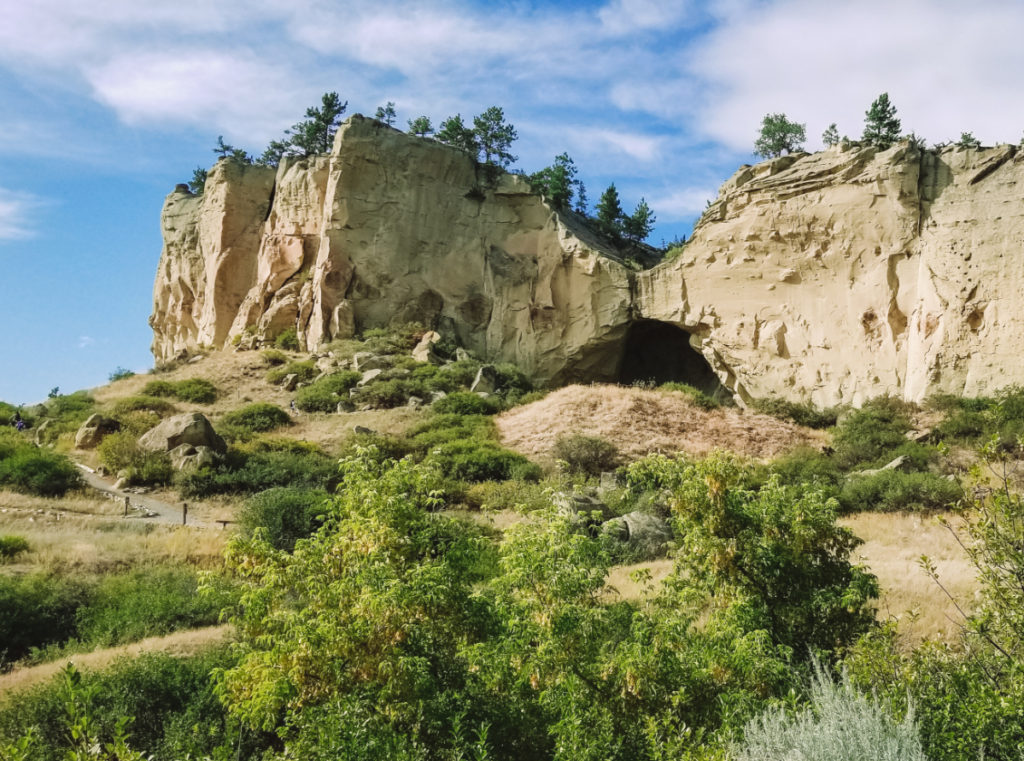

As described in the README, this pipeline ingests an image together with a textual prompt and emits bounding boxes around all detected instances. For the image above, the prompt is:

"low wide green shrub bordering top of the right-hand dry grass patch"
[838,470,964,512]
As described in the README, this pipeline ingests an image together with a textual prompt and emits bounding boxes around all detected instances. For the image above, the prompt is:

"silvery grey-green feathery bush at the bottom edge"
[735,667,927,761]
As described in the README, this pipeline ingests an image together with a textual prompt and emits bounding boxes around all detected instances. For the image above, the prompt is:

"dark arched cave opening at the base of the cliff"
[617,320,732,398]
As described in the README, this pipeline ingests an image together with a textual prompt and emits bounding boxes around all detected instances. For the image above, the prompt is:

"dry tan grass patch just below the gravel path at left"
[0,492,228,573]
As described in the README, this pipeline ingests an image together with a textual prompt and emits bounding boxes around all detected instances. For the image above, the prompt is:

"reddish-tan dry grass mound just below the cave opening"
[495,385,825,463]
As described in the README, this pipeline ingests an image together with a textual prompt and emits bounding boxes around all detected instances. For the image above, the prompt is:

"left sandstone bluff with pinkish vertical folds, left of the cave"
[150,116,631,387]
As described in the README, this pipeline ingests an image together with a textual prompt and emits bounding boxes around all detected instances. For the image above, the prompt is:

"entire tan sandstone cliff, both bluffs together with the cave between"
[151,122,1024,405]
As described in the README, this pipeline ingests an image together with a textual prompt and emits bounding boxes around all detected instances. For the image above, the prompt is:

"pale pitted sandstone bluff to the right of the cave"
[636,142,1024,405]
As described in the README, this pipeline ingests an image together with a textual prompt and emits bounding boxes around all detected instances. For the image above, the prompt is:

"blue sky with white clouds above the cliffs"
[0,0,1024,403]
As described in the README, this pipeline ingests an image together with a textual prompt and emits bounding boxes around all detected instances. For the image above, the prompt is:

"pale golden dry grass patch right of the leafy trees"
[840,513,979,645]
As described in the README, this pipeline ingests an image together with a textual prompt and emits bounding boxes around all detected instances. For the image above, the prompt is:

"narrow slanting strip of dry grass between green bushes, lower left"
[0,624,234,697]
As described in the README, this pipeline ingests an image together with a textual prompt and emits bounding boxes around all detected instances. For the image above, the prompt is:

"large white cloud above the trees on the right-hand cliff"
[689,0,1024,151]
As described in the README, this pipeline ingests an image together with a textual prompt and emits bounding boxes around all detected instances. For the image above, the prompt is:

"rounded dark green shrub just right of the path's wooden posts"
[240,487,329,552]
